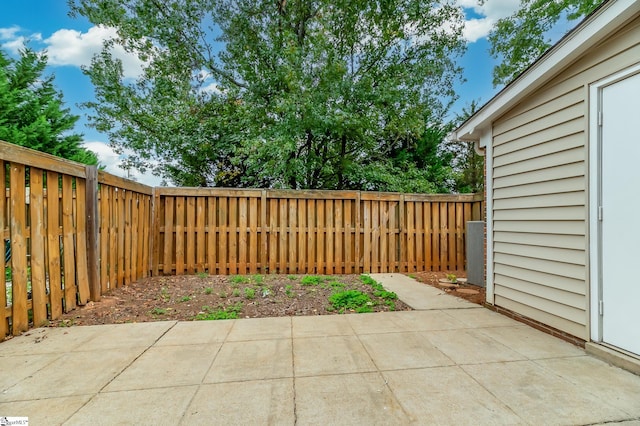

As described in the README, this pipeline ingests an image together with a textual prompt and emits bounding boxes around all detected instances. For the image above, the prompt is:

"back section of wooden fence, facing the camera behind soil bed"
[151,188,483,275]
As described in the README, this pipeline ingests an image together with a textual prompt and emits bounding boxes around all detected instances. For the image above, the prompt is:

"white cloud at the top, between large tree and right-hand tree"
[458,0,520,43]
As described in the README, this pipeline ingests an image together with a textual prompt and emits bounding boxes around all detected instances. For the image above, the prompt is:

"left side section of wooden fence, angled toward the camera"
[0,141,152,340]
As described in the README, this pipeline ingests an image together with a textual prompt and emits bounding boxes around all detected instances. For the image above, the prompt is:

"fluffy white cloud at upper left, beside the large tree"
[44,26,144,78]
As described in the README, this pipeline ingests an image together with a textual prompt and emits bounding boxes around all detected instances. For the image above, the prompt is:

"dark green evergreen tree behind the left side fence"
[0,49,98,164]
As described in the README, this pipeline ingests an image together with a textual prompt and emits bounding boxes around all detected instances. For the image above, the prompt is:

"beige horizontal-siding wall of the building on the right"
[490,16,640,340]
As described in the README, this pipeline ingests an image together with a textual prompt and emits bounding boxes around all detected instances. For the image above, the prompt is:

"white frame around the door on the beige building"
[588,63,640,342]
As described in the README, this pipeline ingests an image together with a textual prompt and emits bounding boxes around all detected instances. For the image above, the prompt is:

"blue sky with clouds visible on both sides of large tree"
[0,0,519,185]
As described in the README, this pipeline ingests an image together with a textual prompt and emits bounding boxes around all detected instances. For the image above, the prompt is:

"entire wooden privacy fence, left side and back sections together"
[0,141,484,340]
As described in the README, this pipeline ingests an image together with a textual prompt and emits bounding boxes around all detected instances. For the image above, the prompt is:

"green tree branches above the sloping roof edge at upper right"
[490,0,603,86]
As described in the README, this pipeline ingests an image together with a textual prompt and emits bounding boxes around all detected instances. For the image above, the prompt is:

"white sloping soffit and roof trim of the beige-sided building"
[455,0,640,147]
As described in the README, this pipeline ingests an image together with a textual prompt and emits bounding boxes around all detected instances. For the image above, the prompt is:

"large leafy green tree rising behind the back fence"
[71,0,465,189]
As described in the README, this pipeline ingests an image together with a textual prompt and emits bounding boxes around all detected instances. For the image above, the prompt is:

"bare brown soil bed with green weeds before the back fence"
[50,272,484,327]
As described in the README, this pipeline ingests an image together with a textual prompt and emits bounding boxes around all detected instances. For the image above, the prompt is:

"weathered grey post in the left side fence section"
[85,166,101,302]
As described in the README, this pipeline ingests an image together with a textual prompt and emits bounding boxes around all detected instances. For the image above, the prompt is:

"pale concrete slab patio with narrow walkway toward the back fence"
[0,274,640,425]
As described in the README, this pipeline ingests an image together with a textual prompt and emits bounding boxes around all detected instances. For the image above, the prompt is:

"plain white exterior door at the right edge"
[600,70,640,355]
